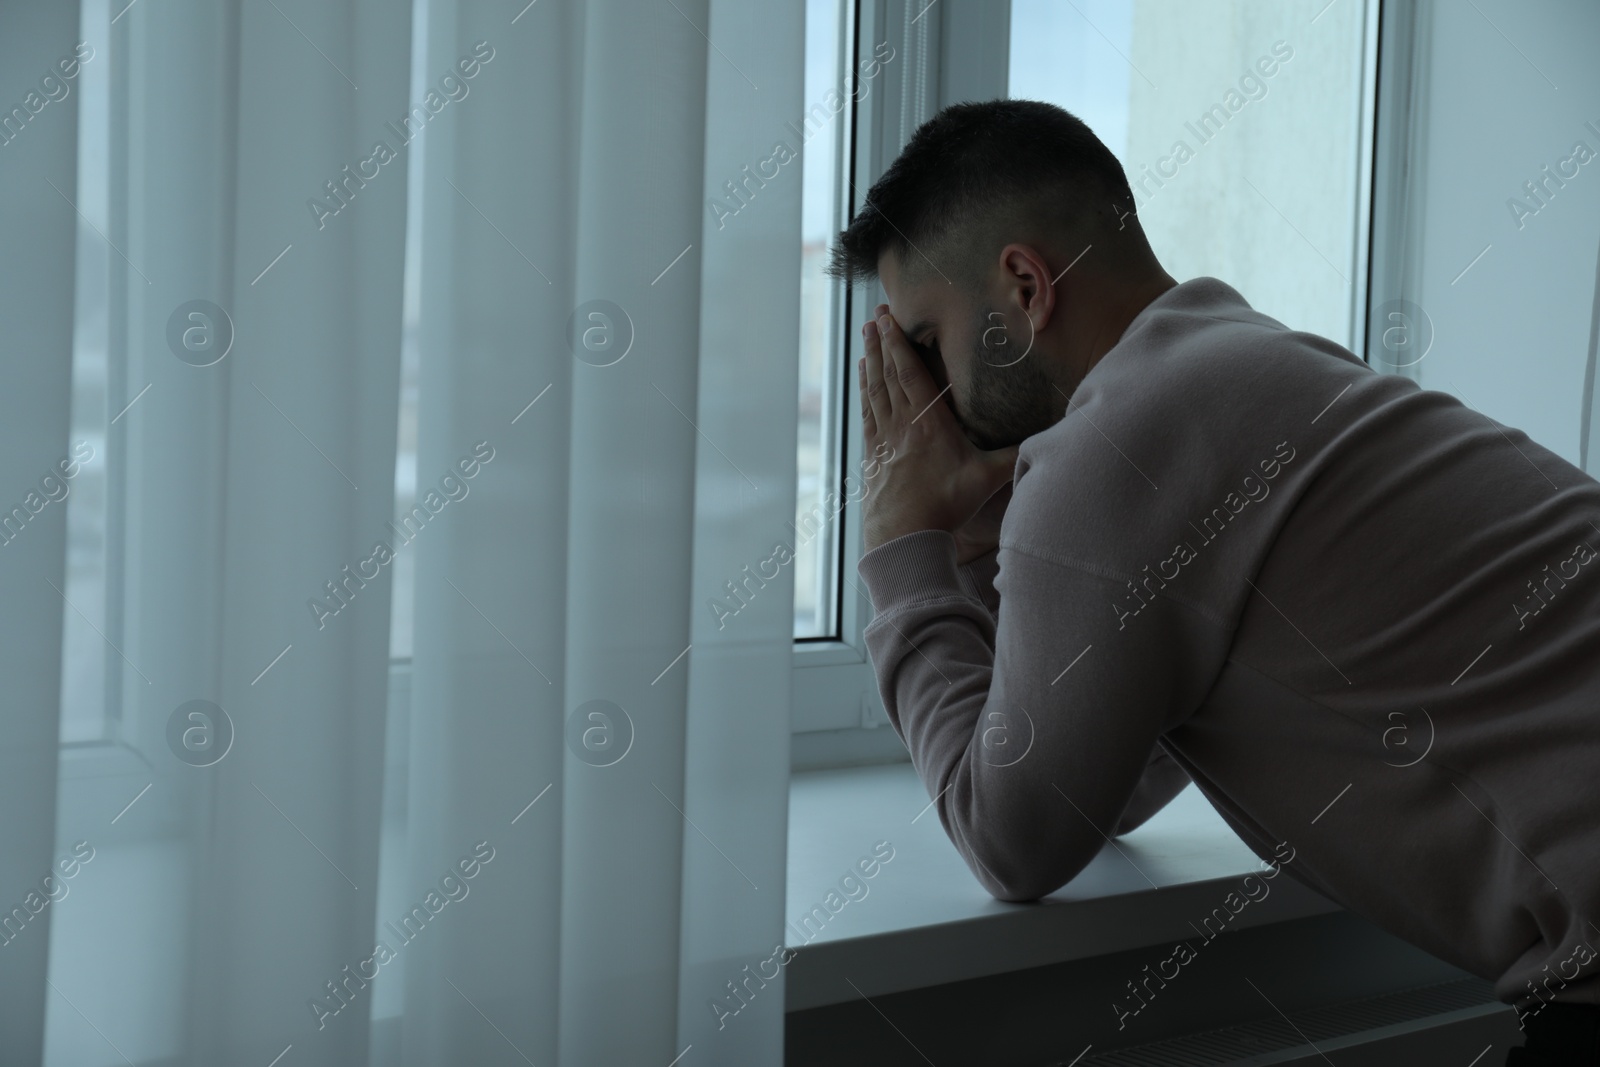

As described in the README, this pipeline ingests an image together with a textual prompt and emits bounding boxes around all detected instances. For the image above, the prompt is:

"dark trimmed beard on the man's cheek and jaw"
[962,303,1066,451]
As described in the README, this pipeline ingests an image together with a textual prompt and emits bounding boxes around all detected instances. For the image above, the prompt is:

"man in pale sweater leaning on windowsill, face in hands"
[829,101,1600,1064]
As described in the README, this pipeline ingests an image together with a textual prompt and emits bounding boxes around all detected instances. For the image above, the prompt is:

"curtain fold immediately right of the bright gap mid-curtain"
[396,0,584,1067]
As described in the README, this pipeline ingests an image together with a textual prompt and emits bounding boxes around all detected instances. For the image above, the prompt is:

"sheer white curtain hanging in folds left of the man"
[0,0,803,1067]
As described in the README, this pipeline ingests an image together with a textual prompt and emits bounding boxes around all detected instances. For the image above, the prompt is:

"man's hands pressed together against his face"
[858,304,1018,563]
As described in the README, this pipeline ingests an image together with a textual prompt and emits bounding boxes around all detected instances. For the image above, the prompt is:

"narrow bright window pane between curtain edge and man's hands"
[794,0,850,638]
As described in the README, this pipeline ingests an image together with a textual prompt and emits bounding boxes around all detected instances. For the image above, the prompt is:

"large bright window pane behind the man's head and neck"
[1010,0,1365,346]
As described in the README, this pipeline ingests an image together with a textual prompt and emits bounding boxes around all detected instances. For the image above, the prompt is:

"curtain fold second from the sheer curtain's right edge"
[560,0,713,1064]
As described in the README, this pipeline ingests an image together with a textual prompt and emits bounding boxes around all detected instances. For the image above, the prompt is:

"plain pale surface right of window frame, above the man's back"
[1368,0,1600,467]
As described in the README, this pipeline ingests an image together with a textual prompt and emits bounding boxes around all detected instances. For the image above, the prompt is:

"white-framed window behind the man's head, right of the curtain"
[792,0,1378,758]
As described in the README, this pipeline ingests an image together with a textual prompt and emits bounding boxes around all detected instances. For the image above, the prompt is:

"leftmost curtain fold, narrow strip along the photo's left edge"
[0,3,78,1062]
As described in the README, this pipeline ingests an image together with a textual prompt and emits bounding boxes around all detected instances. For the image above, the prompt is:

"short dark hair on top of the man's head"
[826,99,1133,288]
